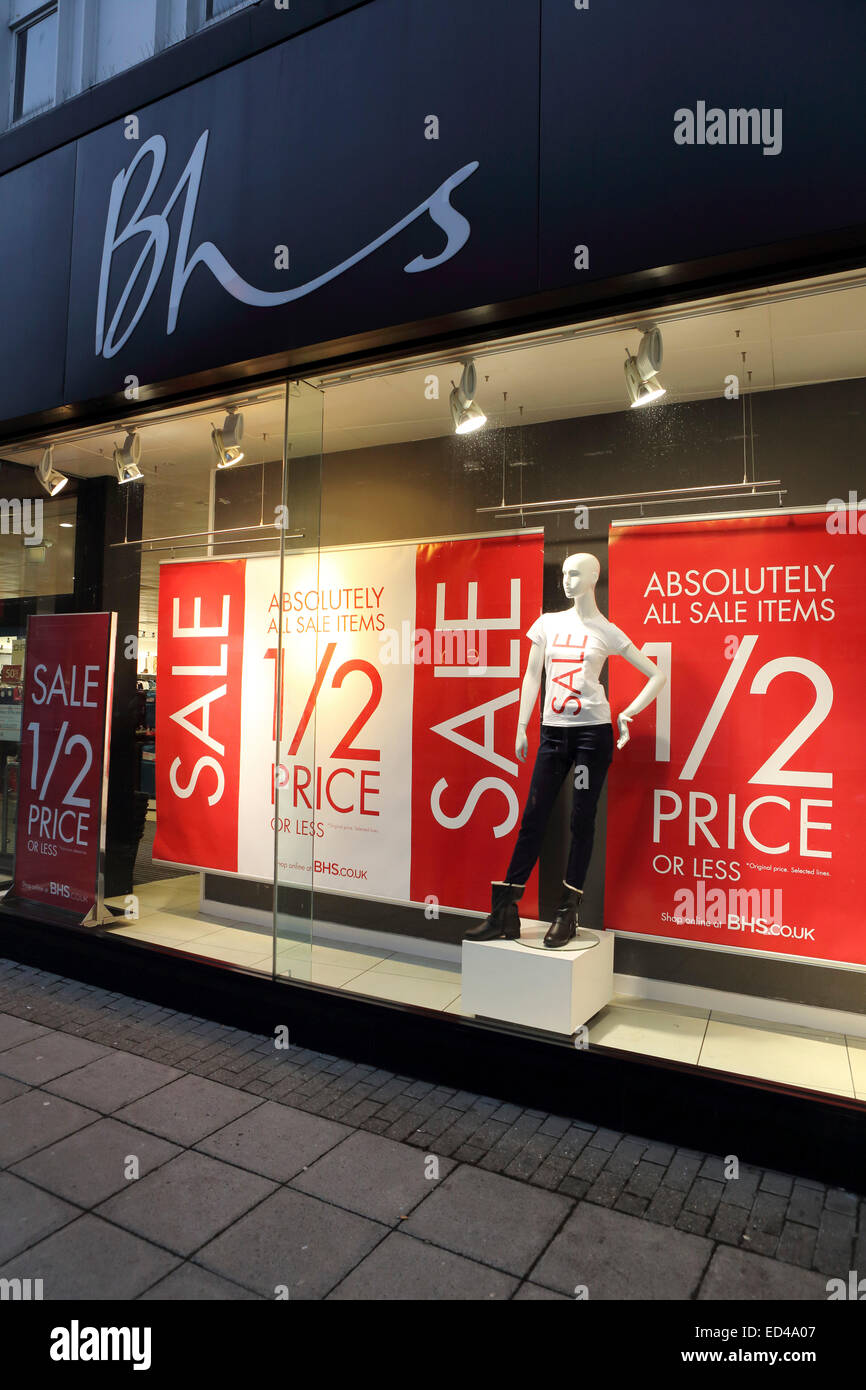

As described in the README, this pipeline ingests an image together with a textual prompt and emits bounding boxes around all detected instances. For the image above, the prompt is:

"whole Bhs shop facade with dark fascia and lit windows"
[0,0,866,1180]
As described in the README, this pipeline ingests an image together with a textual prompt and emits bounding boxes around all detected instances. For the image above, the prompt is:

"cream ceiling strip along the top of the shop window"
[6,285,866,475]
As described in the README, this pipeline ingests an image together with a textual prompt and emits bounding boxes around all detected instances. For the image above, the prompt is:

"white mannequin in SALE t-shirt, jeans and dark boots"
[464,555,666,948]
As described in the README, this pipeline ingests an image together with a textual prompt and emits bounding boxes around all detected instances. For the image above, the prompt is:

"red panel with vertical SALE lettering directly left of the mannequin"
[411,534,542,917]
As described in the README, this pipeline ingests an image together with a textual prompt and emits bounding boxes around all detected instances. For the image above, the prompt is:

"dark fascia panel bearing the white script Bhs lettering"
[61,0,538,402]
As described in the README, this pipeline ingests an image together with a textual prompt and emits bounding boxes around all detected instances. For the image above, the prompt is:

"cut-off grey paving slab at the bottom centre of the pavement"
[328,1232,517,1302]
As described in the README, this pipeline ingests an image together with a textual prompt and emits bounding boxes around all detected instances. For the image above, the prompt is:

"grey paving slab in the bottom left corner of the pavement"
[3,1213,178,1302]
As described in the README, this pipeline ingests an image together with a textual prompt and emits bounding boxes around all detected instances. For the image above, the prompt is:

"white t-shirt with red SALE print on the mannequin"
[527,607,630,728]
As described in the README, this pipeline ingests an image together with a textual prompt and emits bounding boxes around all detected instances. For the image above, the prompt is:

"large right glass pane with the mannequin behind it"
[291,268,866,1098]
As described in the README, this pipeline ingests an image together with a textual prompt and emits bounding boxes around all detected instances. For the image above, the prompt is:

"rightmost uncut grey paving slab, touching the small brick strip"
[402,1165,573,1275]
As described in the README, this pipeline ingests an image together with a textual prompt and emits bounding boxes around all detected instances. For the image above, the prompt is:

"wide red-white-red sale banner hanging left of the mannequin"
[154,532,542,909]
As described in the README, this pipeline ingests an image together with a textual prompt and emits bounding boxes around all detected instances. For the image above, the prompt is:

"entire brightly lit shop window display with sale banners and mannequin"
[0,268,866,1099]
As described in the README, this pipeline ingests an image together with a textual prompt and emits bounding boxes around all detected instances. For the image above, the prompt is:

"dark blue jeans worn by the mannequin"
[505,724,613,888]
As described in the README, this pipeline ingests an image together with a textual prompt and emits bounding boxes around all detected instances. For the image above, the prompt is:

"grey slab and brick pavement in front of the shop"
[0,960,866,1301]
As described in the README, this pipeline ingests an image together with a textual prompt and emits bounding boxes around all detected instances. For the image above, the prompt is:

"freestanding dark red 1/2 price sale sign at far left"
[13,613,117,920]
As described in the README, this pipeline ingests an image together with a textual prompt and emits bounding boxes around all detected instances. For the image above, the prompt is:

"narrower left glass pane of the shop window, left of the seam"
[0,384,321,976]
